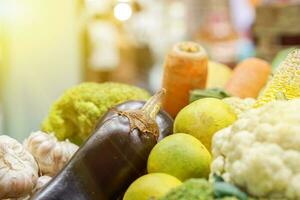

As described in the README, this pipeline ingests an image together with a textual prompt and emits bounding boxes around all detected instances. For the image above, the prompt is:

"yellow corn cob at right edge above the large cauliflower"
[254,49,300,108]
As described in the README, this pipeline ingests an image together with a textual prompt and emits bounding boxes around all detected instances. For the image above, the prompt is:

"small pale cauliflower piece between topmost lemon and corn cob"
[223,97,256,116]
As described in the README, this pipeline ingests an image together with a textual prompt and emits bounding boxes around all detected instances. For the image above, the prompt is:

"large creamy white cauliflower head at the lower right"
[211,99,300,199]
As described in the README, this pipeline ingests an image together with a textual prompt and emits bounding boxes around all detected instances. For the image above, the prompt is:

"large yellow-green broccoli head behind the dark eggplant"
[42,82,150,144]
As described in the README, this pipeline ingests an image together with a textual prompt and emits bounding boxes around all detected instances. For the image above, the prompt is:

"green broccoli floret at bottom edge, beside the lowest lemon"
[159,179,214,200]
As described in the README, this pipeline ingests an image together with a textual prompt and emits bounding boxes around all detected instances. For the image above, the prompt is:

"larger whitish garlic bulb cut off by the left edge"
[0,135,38,199]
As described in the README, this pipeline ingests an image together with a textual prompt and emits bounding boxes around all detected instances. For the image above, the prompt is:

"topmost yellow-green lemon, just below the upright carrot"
[174,98,237,151]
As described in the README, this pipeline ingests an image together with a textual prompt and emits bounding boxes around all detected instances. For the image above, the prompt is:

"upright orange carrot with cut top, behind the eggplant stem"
[162,42,208,117]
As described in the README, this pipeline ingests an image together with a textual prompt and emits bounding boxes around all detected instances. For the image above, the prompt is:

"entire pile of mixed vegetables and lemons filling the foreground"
[0,42,300,200]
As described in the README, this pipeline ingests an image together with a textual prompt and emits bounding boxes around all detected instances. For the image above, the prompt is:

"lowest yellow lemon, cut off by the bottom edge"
[123,173,181,200]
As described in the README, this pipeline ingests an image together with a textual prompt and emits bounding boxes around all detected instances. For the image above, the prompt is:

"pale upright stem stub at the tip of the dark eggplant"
[142,88,166,120]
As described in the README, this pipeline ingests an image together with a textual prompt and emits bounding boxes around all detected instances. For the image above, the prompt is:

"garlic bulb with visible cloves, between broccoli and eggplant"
[24,131,78,177]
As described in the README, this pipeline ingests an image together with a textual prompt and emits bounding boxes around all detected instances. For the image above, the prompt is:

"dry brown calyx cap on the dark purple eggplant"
[118,110,159,140]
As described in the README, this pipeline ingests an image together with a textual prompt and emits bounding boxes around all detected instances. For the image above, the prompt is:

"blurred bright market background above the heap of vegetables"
[0,0,300,140]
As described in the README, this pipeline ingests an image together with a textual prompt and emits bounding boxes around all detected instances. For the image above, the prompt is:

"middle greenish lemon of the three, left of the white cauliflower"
[147,133,211,181]
